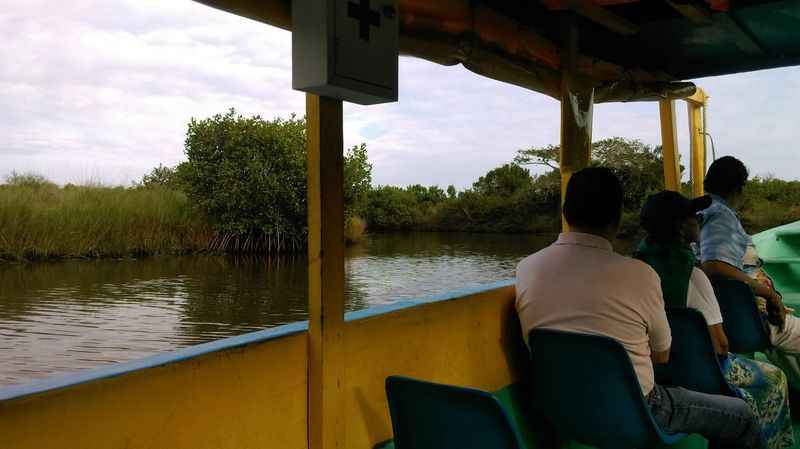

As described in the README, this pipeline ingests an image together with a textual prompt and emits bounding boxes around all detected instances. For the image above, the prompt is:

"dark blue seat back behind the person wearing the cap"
[667,308,735,396]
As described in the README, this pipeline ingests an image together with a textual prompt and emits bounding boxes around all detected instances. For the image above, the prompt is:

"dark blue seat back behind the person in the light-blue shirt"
[711,277,770,353]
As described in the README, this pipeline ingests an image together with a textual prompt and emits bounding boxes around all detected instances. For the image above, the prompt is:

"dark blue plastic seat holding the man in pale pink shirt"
[530,329,685,449]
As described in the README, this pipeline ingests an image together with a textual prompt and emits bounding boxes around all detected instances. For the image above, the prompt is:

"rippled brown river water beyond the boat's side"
[0,233,636,386]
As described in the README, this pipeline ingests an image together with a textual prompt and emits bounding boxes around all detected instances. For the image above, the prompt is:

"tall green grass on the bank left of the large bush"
[0,174,213,260]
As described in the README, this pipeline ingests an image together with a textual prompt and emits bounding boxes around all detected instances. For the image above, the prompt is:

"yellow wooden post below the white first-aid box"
[306,94,345,449]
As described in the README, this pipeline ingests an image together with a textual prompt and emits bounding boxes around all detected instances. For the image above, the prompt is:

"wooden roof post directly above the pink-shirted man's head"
[560,14,594,231]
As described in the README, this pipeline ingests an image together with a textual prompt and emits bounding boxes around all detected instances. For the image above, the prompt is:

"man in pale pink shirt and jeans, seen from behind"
[515,167,766,449]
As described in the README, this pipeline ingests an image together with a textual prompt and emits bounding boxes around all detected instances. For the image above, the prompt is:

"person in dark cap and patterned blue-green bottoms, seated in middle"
[634,191,794,449]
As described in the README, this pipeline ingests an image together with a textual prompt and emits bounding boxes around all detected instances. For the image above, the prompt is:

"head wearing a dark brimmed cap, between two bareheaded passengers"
[640,190,711,244]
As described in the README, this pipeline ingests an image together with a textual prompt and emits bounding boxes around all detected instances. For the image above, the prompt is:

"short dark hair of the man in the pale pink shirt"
[564,167,622,229]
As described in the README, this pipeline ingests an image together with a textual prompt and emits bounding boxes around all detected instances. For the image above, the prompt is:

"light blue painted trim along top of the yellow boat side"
[0,280,514,401]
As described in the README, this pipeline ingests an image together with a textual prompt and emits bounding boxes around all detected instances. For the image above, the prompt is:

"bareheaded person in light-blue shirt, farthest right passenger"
[699,156,800,390]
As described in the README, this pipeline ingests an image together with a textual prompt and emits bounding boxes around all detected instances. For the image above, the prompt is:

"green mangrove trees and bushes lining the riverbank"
[140,109,800,252]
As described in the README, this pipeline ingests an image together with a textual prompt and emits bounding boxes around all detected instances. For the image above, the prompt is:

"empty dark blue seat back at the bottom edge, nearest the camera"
[386,376,523,449]
